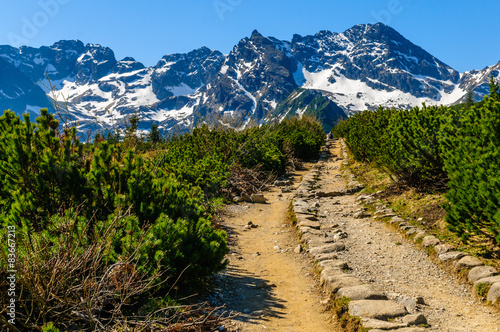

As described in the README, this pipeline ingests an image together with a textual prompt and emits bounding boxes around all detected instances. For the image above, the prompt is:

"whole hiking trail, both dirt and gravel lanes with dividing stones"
[211,141,500,332]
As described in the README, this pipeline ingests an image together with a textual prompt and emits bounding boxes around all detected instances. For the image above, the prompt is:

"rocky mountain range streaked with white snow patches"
[0,23,500,134]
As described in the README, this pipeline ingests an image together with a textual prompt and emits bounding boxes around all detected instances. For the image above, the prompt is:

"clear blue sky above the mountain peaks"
[0,0,500,71]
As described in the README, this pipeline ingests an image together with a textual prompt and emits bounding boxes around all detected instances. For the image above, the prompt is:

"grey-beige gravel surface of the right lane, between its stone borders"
[317,142,500,332]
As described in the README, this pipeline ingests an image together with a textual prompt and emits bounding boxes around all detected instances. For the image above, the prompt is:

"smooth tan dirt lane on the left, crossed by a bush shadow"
[213,170,340,332]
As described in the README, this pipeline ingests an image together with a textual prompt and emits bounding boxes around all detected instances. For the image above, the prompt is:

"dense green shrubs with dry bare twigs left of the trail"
[0,109,325,331]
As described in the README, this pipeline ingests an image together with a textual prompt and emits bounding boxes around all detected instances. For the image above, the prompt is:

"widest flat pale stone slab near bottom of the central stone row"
[349,300,408,320]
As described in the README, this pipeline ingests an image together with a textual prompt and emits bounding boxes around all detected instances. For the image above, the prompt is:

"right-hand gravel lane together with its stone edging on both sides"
[292,141,500,332]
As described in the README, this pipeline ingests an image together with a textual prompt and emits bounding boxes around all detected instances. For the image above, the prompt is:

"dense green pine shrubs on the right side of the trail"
[333,80,500,244]
